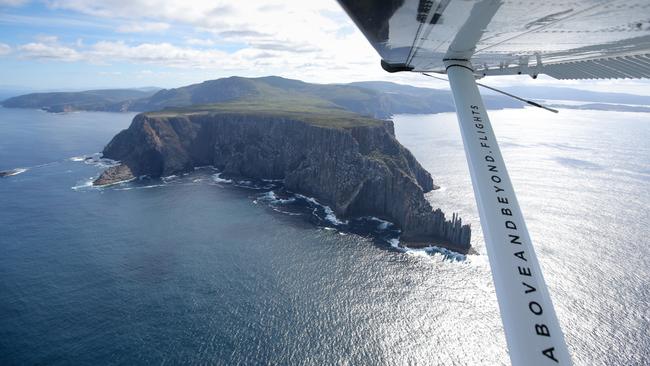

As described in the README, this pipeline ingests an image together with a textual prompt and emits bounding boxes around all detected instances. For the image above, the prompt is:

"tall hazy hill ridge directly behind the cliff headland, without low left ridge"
[125,76,522,118]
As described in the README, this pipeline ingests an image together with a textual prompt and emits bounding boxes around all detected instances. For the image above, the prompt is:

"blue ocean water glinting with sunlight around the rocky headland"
[0,104,650,365]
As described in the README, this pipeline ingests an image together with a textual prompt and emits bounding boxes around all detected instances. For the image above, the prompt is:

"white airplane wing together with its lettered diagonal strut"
[338,0,650,365]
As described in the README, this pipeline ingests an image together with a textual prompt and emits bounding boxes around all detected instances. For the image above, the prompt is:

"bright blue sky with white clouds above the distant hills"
[0,0,650,95]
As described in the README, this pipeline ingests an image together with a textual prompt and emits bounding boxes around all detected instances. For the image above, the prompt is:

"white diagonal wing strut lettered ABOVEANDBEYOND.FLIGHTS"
[446,60,571,366]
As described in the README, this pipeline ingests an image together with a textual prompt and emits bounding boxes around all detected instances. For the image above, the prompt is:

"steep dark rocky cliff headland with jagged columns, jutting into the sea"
[95,111,470,251]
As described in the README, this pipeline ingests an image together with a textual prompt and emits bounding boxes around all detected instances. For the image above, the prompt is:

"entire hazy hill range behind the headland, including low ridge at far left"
[3,76,522,118]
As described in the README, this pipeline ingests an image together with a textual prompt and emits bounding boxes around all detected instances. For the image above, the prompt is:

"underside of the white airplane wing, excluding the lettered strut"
[339,0,650,79]
